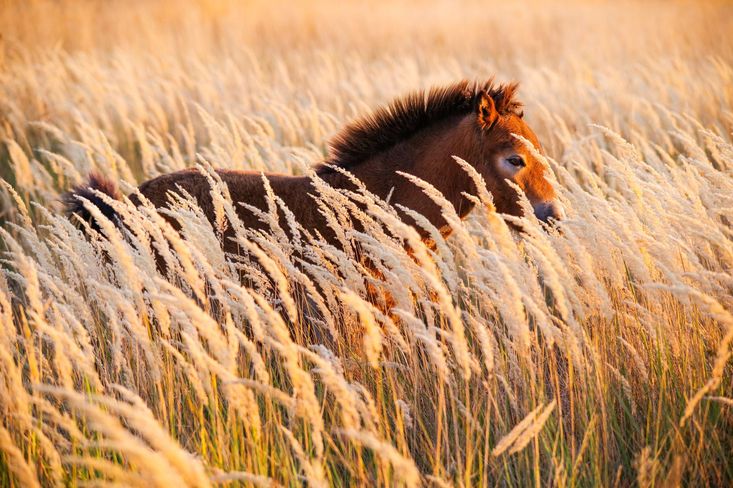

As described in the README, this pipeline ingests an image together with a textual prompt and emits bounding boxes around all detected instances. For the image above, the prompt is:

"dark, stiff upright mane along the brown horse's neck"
[316,78,522,172]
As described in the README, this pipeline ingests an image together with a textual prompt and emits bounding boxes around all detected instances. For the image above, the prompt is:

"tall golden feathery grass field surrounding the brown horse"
[0,0,733,487]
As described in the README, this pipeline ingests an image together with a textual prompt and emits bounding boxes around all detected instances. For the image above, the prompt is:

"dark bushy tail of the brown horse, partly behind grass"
[62,173,122,231]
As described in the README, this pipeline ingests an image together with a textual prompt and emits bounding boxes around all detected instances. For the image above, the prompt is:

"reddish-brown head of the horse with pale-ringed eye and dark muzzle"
[467,84,564,222]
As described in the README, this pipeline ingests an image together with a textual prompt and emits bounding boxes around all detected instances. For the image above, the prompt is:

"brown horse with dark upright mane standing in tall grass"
[65,80,562,252]
